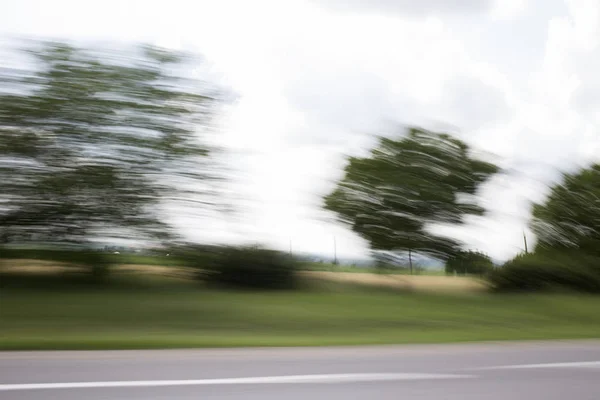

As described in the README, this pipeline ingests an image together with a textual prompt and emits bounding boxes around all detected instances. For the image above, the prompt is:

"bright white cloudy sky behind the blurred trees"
[0,0,600,260]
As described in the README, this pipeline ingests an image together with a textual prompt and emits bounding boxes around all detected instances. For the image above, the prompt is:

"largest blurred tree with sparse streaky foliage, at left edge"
[0,43,225,247]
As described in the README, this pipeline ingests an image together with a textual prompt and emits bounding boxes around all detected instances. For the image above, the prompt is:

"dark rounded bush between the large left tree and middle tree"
[207,247,297,289]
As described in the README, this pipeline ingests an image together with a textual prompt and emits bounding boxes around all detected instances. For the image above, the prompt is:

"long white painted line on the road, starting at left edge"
[0,373,474,391]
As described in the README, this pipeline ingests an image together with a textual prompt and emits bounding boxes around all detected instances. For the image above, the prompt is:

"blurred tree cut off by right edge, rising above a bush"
[531,164,600,256]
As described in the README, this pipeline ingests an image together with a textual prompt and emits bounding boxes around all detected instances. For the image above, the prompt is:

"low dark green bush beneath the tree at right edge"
[489,251,600,293]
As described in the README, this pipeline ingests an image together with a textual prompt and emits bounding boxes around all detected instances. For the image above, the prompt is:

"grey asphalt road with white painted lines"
[0,341,600,400]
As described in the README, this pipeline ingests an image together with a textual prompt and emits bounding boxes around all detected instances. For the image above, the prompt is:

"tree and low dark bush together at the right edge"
[490,164,600,293]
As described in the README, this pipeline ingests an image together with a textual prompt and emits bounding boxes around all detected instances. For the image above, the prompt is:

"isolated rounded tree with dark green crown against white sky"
[325,128,498,262]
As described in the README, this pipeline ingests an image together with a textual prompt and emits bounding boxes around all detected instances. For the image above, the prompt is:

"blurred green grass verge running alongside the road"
[0,272,600,350]
